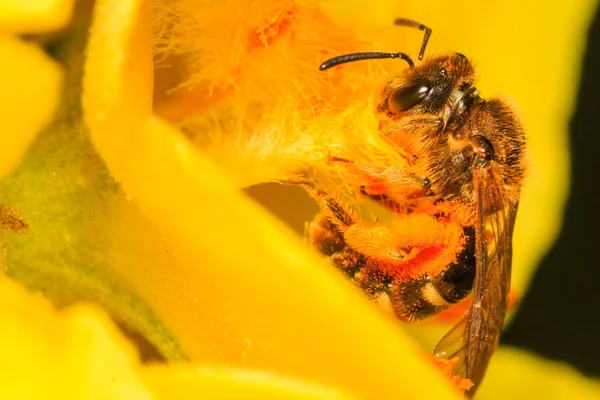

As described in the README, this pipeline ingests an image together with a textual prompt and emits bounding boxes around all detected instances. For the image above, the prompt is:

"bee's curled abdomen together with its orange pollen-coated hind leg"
[299,181,475,322]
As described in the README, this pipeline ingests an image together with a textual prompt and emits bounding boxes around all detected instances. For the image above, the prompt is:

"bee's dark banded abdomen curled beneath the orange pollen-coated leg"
[297,181,475,322]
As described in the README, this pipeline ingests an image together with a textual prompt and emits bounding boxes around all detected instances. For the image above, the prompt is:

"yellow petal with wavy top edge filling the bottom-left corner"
[0,278,152,400]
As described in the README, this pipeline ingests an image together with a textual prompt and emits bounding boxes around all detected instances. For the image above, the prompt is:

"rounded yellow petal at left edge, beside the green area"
[0,36,62,179]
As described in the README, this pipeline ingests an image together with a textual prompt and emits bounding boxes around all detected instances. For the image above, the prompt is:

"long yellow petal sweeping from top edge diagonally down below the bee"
[83,0,452,399]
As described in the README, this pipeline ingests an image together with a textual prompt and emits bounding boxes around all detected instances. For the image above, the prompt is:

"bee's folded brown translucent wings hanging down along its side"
[435,169,518,395]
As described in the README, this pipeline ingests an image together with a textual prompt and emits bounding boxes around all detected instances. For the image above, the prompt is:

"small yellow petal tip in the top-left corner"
[0,0,75,33]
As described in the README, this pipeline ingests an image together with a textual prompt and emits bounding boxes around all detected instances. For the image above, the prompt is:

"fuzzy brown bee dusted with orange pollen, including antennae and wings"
[296,19,525,396]
